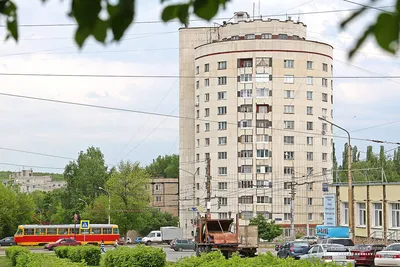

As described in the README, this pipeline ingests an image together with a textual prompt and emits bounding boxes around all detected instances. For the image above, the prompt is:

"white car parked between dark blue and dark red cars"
[300,244,355,266]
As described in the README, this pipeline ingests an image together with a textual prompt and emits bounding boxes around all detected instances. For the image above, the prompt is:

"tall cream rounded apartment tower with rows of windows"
[180,12,333,239]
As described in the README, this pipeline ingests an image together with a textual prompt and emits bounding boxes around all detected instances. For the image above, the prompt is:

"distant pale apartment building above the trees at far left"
[4,170,66,193]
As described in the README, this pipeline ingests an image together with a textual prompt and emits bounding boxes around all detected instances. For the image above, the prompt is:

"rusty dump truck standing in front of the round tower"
[195,216,258,258]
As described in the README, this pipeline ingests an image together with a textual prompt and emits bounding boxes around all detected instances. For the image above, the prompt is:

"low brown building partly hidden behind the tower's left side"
[151,177,179,216]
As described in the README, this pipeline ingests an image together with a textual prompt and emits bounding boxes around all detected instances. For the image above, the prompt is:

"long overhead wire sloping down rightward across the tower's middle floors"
[0,93,400,147]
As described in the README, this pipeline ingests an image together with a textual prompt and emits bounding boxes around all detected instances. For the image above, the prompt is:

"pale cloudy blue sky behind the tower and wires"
[0,0,400,172]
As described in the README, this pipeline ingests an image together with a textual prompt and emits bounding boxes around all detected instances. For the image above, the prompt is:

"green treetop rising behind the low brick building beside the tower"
[146,154,179,178]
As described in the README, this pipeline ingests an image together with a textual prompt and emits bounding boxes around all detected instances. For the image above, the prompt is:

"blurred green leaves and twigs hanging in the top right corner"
[341,3,400,58]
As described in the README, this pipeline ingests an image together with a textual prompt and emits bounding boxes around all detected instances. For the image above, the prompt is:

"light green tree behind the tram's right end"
[106,161,150,239]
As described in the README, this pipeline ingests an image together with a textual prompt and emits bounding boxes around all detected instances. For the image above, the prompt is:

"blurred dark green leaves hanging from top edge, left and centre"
[0,0,229,47]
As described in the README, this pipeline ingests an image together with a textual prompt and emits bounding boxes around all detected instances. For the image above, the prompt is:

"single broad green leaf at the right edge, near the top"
[374,13,400,54]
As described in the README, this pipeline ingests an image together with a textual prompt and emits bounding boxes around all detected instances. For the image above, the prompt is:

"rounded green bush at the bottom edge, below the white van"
[103,245,167,267]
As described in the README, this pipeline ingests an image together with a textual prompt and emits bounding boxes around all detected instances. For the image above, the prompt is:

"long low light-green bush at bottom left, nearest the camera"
[16,253,86,267]
